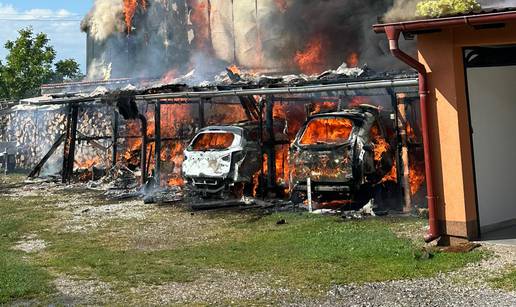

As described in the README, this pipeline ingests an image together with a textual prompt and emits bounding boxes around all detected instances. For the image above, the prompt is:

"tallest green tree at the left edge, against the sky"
[2,27,56,99]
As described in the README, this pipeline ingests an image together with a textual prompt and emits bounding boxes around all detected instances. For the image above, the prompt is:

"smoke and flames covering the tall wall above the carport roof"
[84,0,420,81]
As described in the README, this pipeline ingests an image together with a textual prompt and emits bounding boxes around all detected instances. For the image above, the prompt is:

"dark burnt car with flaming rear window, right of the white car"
[290,105,395,205]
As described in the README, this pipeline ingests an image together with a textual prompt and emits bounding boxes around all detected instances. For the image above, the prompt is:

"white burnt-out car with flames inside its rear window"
[182,125,260,196]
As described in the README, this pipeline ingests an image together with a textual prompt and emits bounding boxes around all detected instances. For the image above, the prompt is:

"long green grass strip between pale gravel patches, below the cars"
[40,214,482,291]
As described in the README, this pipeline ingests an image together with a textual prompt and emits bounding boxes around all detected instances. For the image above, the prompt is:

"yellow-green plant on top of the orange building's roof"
[416,0,481,18]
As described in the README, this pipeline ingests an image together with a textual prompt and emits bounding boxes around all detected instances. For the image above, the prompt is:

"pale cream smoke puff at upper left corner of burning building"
[82,0,125,41]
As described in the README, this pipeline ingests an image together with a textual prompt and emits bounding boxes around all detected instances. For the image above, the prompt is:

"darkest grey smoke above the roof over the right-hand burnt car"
[278,0,408,70]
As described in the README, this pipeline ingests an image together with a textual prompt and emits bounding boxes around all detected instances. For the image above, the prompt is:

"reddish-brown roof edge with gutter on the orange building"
[373,10,516,33]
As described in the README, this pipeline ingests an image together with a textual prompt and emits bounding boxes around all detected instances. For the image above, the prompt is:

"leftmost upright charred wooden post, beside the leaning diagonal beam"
[62,104,79,183]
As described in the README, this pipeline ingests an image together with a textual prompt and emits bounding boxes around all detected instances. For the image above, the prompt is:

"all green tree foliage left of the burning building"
[0,27,82,100]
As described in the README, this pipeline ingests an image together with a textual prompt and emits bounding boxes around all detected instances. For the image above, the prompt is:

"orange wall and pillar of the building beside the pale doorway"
[418,23,516,239]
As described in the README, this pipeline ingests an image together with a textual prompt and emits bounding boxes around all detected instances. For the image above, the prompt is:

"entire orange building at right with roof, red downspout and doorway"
[374,9,516,244]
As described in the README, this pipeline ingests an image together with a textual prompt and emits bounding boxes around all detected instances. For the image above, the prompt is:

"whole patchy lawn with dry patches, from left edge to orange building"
[0,176,488,303]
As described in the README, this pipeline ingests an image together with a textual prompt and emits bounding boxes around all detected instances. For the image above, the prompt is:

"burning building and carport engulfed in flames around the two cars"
[0,0,430,214]
